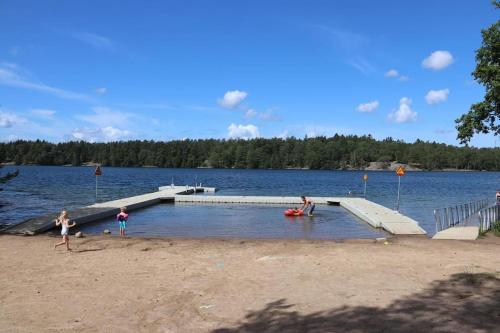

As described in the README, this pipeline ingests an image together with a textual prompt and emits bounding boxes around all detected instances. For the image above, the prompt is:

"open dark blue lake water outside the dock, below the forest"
[0,166,500,234]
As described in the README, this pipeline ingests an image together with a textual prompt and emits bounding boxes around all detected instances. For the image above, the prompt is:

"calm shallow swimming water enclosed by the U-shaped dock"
[80,204,386,239]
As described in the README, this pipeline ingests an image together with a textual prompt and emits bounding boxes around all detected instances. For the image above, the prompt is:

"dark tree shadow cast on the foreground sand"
[213,273,500,333]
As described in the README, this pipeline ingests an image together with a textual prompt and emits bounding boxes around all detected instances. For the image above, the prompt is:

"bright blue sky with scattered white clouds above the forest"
[0,0,500,147]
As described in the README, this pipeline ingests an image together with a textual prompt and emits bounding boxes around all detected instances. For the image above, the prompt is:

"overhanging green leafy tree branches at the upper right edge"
[455,0,500,143]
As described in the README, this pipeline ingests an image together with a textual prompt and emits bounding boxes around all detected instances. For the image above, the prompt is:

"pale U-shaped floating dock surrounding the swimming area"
[3,185,426,235]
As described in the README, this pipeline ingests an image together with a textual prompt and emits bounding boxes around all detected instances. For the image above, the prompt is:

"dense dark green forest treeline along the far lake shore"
[0,135,500,170]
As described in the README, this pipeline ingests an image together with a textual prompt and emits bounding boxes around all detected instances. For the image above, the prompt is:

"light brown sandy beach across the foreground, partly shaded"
[0,235,500,333]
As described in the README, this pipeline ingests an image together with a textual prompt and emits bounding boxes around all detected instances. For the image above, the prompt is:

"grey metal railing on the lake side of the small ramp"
[434,199,489,232]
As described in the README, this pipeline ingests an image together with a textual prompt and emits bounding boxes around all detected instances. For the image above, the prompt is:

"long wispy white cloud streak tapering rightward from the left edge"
[0,63,90,101]
